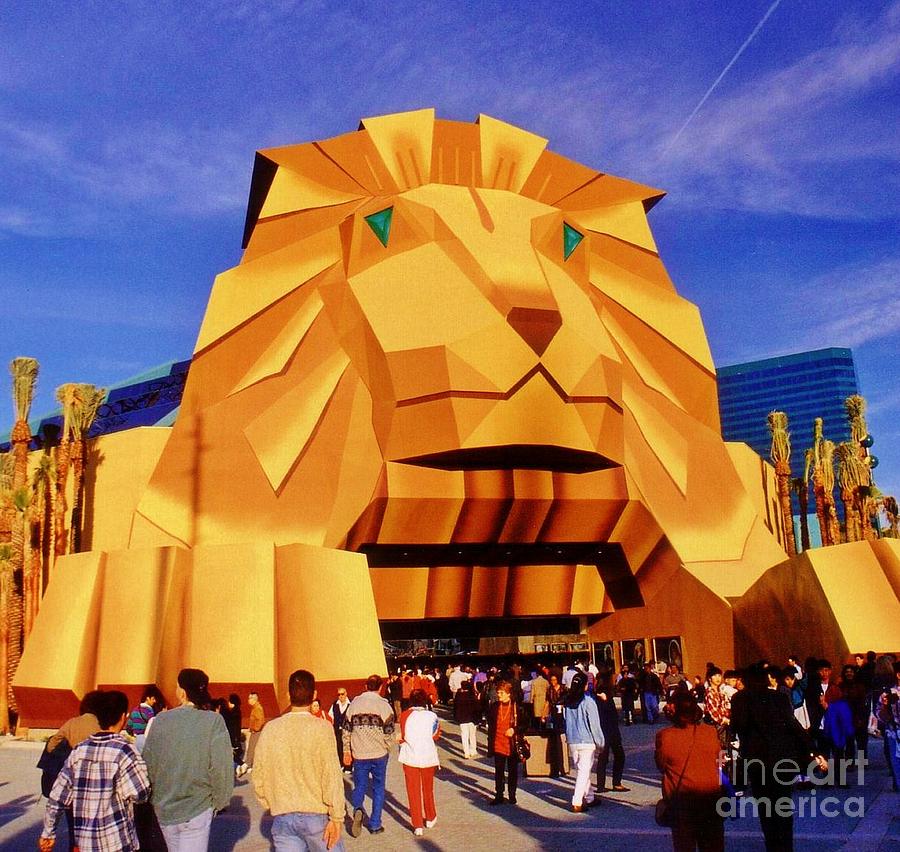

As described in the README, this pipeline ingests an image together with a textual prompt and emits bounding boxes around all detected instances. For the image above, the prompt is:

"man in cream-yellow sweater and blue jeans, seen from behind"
[253,669,344,852]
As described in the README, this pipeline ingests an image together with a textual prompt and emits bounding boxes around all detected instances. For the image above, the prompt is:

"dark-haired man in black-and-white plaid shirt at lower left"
[39,691,150,852]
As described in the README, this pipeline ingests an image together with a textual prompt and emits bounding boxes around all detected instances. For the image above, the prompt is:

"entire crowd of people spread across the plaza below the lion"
[31,653,900,852]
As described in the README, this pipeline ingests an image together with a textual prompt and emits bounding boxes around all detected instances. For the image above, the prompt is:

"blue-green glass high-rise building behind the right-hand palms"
[716,349,859,456]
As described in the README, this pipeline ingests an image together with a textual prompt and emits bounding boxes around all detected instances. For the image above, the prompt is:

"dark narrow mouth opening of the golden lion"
[398,444,619,473]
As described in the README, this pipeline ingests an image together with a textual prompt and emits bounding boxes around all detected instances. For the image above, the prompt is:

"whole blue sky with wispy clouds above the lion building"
[0,0,900,500]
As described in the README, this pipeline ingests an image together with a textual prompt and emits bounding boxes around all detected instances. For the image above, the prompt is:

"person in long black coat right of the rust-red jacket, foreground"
[731,664,828,852]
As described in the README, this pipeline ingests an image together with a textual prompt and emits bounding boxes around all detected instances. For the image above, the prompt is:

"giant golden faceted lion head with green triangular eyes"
[131,110,783,619]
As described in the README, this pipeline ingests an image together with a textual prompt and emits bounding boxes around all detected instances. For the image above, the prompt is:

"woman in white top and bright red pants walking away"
[400,689,441,837]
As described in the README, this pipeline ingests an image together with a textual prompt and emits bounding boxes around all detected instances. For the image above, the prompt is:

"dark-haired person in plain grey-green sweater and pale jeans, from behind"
[143,669,234,852]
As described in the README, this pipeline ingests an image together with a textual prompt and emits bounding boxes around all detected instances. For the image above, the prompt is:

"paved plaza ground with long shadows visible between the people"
[0,721,900,852]
